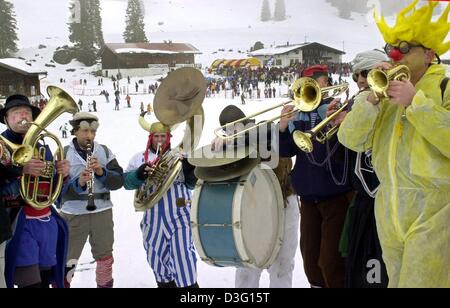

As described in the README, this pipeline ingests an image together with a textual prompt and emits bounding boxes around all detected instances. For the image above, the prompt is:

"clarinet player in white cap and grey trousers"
[61,112,123,288]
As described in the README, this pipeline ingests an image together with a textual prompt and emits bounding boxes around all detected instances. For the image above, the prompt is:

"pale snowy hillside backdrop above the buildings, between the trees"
[11,0,448,65]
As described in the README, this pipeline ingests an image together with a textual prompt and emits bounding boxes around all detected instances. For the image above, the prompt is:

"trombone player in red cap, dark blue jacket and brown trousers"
[279,65,353,287]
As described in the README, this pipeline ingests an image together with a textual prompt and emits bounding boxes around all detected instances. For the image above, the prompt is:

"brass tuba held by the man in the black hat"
[2,86,78,209]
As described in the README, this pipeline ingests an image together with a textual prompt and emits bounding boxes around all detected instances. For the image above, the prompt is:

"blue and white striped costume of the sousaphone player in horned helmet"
[125,152,197,287]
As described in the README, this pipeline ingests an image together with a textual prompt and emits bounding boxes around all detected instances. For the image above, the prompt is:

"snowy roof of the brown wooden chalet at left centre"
[105,42,201,54]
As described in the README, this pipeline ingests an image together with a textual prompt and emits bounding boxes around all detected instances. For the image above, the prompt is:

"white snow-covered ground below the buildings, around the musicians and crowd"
[4,40,366,288]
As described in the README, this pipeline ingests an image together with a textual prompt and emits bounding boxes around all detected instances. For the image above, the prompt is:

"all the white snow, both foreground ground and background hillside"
[0,0,448,288]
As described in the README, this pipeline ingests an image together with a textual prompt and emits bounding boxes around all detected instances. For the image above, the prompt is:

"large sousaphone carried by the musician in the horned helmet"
[134,67,206,211]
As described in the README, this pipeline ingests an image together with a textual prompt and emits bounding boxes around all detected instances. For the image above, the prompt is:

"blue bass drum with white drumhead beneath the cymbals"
[191,165,284,269]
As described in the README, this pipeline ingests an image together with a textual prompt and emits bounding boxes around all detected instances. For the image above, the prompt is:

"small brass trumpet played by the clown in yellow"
[367,64,411,99]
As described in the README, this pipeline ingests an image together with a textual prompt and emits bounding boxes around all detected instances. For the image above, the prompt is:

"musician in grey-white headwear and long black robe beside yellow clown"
[329,49,388,288]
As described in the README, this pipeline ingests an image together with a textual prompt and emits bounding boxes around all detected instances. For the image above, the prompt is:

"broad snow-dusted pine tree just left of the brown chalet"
[69,0,104,65]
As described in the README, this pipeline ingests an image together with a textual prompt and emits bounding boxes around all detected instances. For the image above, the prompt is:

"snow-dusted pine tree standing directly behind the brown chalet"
[123,0,148,43]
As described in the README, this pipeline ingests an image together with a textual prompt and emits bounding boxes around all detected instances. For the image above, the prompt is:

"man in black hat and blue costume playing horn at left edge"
[0,94,70,288]
